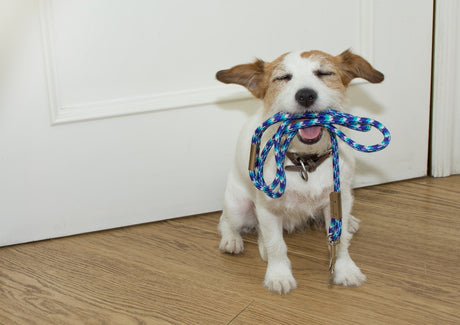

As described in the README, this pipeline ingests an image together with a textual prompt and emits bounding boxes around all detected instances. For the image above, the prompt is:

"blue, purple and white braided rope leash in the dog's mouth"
[249,109,391,275]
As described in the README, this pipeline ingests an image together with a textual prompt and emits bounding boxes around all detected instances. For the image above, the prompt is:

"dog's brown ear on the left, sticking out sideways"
[216,59,266,99]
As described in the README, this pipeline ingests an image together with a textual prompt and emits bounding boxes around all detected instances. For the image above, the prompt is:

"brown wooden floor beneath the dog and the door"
[0,176,460,324]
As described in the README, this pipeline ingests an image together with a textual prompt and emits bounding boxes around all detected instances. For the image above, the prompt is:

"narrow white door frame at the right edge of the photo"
[431,0,460,176]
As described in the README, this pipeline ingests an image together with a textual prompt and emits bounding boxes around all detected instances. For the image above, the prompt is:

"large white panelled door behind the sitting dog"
[0,0,433,245]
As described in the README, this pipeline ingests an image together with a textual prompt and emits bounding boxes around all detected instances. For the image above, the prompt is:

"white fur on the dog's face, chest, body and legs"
[219,52,366,294]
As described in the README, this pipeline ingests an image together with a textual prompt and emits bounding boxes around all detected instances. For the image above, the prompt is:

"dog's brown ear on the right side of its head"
[336,50,384,86]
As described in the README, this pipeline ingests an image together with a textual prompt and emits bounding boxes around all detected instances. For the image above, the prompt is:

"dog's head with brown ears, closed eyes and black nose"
[216,50,384,143]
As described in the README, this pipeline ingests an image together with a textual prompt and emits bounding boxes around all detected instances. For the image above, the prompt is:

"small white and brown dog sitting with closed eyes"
[216,50,384,294]
